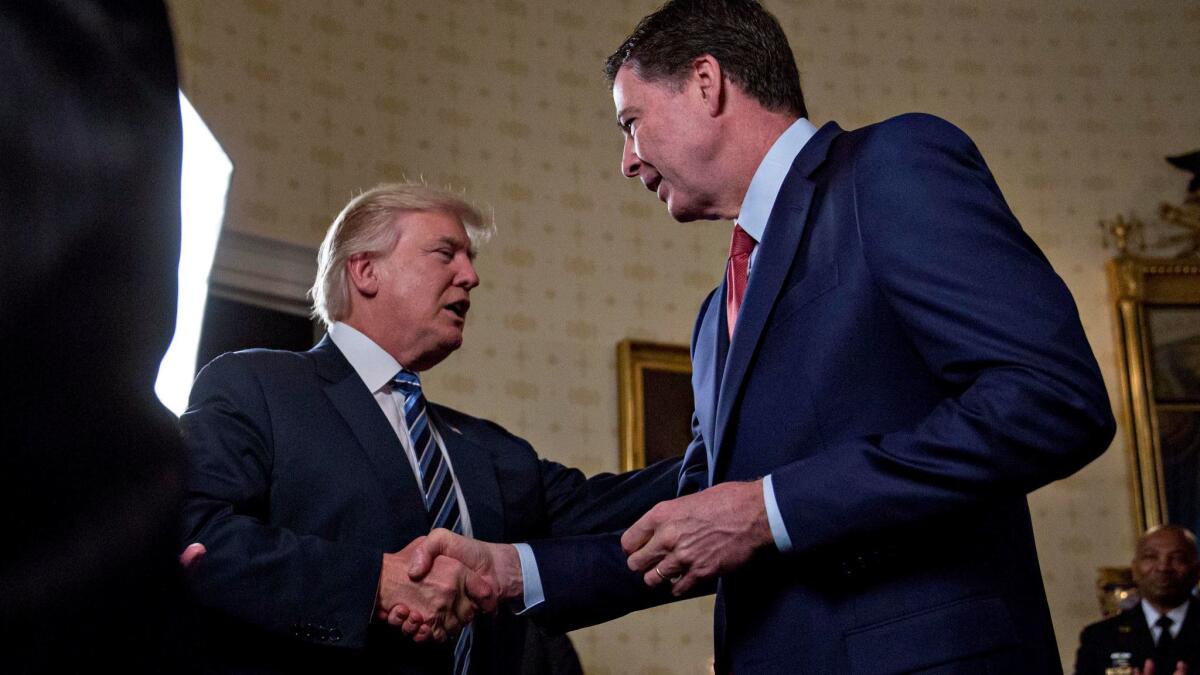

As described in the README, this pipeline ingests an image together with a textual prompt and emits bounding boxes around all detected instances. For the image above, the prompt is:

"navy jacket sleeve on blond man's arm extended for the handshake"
[181,354,383,647]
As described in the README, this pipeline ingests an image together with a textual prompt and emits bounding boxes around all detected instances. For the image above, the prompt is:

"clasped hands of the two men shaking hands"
[376,528,524,643]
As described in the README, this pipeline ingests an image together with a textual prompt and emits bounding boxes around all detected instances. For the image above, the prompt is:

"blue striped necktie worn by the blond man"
[391,369,473,675]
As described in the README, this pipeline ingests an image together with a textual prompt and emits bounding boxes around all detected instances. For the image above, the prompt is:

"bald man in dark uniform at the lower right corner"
[1075,525,1200,675]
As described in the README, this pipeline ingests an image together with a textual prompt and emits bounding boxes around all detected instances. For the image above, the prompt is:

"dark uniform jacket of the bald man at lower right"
[1075,601,1200,675]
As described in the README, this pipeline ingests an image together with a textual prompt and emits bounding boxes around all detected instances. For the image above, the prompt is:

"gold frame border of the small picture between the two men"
[617,340,691,471]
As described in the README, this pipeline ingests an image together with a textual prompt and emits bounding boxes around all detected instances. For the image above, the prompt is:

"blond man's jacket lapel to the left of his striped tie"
[310,335,430,531]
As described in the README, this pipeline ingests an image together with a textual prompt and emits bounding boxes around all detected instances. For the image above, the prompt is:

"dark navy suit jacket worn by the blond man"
[182,338,678,673]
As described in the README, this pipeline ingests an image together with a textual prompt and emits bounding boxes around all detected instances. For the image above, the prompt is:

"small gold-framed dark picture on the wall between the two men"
[617,340,692,471]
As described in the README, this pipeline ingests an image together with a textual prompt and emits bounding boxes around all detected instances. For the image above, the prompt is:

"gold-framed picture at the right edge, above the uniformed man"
[1108,256,1200,532]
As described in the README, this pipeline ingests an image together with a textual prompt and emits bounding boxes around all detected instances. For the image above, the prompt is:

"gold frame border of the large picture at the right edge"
[1108,256,1200,532]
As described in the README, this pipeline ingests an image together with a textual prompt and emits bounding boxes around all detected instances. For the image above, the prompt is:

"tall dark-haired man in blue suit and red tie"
[418,0,1114,674]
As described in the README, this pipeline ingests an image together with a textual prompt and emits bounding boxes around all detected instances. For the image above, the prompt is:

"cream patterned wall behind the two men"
[169,0,1200,674]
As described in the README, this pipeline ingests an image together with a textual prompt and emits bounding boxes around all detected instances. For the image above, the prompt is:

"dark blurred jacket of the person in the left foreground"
[0,0,186,674]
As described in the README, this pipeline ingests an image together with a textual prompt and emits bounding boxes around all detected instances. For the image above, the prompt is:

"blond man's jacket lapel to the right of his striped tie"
[428,405,504,542]
